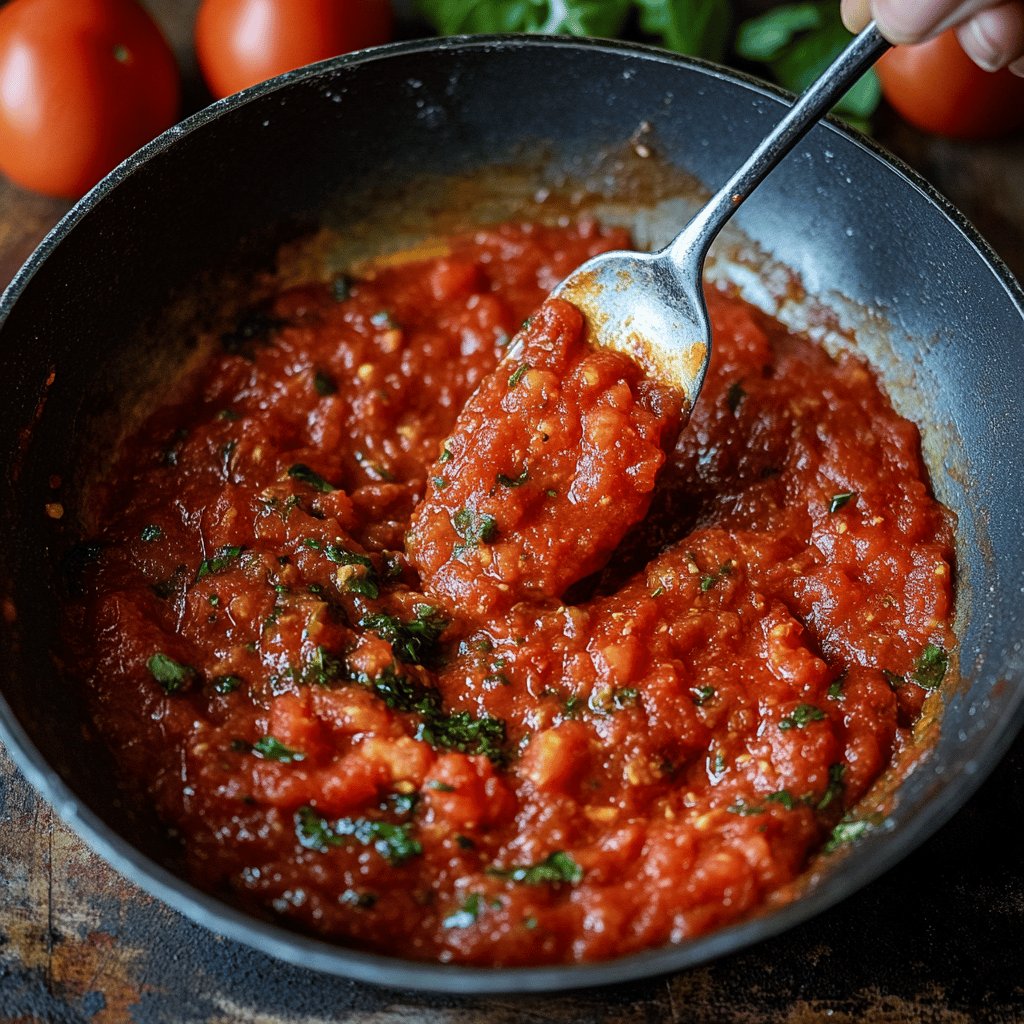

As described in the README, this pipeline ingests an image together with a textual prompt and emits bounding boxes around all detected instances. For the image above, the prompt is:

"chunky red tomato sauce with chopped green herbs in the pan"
[71,223,953,965]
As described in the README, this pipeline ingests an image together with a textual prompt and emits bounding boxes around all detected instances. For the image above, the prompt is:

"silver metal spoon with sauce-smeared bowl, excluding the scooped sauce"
[536,22,891,409]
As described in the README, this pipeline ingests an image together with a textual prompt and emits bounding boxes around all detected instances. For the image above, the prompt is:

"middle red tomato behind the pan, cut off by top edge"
[196,0,391,98]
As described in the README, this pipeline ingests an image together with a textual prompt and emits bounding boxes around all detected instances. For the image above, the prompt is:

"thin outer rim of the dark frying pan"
[0,29,1024,995]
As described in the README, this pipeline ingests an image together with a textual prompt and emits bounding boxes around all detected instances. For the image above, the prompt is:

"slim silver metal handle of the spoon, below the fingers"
[669,22,892,263]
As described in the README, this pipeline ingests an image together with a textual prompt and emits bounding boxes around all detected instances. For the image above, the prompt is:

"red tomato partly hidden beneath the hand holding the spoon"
[878,29,1024,138]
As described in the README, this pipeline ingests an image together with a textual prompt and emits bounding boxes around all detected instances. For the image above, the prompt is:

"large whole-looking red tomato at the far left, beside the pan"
[0,0,180,199]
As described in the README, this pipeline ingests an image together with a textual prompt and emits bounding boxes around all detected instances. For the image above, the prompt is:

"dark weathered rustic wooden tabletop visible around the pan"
[0,0,1024,1024]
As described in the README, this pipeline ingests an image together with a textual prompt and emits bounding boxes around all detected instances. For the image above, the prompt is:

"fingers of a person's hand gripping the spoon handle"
[842,0,1024,77]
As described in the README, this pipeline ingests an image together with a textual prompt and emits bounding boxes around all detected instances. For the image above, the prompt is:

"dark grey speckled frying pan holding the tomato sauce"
[0,37,1024,992]
